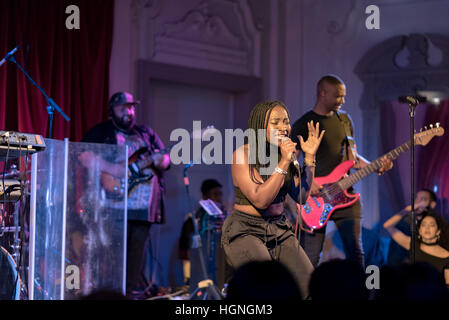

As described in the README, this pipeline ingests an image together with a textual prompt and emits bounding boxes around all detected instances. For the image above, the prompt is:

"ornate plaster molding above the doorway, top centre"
[151,0,261,76]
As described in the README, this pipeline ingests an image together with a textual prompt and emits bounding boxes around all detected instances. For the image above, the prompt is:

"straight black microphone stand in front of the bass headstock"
[408,100,419,263]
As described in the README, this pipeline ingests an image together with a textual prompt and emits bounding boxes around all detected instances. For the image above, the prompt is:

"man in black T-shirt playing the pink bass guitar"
[291,75,393,267]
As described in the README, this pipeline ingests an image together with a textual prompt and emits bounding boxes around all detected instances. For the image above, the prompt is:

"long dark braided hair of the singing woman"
[247,101,290,184]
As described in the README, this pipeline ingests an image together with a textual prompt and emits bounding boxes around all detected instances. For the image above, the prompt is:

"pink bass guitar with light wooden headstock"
[297,123,444,230]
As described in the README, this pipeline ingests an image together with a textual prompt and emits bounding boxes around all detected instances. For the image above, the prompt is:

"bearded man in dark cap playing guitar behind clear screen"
[79,92,170,298]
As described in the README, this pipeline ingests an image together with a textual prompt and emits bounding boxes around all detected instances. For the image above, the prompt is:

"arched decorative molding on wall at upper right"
[355,34,449,103]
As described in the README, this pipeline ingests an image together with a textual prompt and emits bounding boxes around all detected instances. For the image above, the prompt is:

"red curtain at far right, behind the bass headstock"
[418,100,449,219]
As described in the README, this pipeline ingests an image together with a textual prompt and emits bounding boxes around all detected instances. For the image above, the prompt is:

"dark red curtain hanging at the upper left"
[0,0,114,141]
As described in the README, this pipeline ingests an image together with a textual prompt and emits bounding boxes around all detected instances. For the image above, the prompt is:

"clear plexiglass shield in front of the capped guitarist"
[28,139,128,300]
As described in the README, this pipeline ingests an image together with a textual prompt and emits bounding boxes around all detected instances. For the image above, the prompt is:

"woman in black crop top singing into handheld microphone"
[222,101,324,298]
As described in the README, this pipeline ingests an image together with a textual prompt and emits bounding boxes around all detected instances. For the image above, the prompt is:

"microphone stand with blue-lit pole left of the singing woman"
[184,163,222,300]
